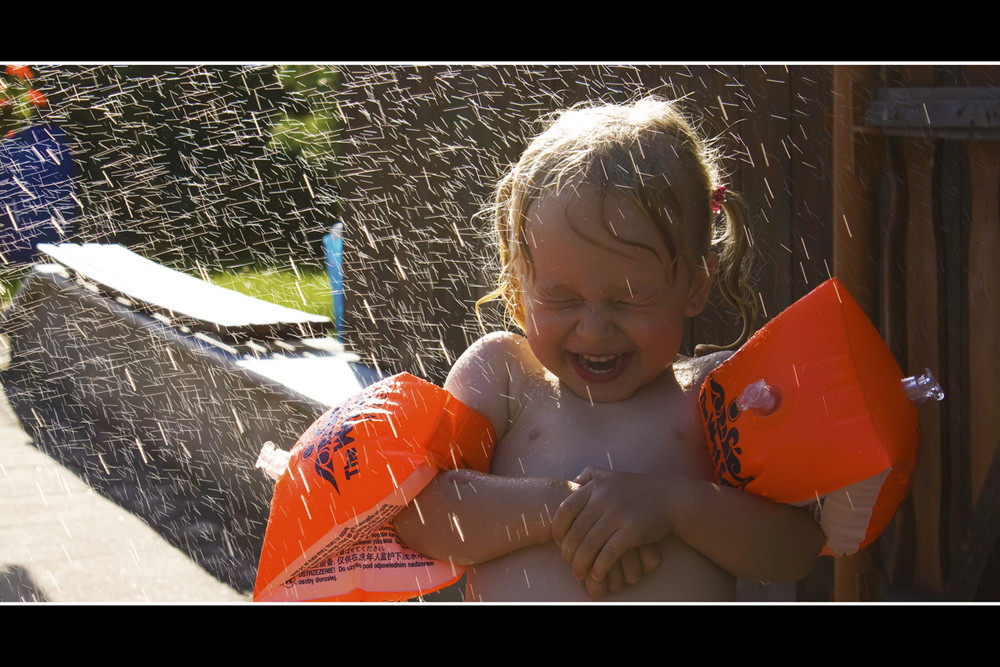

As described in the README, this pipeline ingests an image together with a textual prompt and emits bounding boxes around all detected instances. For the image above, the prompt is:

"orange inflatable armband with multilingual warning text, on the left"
[254,373,496,601]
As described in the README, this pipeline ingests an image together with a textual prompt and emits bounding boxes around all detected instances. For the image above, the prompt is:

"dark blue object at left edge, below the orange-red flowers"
[0,125,77,265]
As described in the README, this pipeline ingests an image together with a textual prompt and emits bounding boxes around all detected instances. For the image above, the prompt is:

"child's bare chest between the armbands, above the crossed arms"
[492,374,709,479]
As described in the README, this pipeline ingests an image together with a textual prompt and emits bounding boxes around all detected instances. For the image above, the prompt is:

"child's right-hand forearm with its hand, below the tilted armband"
[553,469,824,581]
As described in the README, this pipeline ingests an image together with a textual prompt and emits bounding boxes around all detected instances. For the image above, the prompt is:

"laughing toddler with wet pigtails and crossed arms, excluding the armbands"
[396,98,823,601]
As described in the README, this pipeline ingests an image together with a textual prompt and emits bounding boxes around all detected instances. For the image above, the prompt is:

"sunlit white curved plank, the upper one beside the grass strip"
[39,243,331,335]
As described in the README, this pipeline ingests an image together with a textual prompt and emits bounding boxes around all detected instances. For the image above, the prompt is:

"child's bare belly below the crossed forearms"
[467,537,736,602]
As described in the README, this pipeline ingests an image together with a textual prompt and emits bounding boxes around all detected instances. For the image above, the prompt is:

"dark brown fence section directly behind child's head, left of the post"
[338,65,832,381]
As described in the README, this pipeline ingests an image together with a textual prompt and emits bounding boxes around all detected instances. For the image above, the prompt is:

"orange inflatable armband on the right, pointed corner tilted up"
[699,278,944,555]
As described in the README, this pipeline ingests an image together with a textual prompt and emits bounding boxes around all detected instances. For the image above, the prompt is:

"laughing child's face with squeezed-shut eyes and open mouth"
[522,180,711,402]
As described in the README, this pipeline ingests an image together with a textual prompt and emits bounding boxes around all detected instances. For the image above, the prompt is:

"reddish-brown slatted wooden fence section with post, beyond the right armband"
[833,66,1000,601]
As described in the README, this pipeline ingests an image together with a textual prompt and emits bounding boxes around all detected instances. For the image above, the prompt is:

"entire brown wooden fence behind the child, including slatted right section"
[339,65,1000,600]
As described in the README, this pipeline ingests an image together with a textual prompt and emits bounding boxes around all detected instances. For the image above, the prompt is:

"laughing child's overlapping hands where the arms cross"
[552,468,674,595]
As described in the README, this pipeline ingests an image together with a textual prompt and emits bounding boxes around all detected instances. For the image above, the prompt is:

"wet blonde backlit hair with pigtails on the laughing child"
[476,97,756,352]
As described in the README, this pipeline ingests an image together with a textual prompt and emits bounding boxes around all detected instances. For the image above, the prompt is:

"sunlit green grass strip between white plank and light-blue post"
[205,267,333,319]
